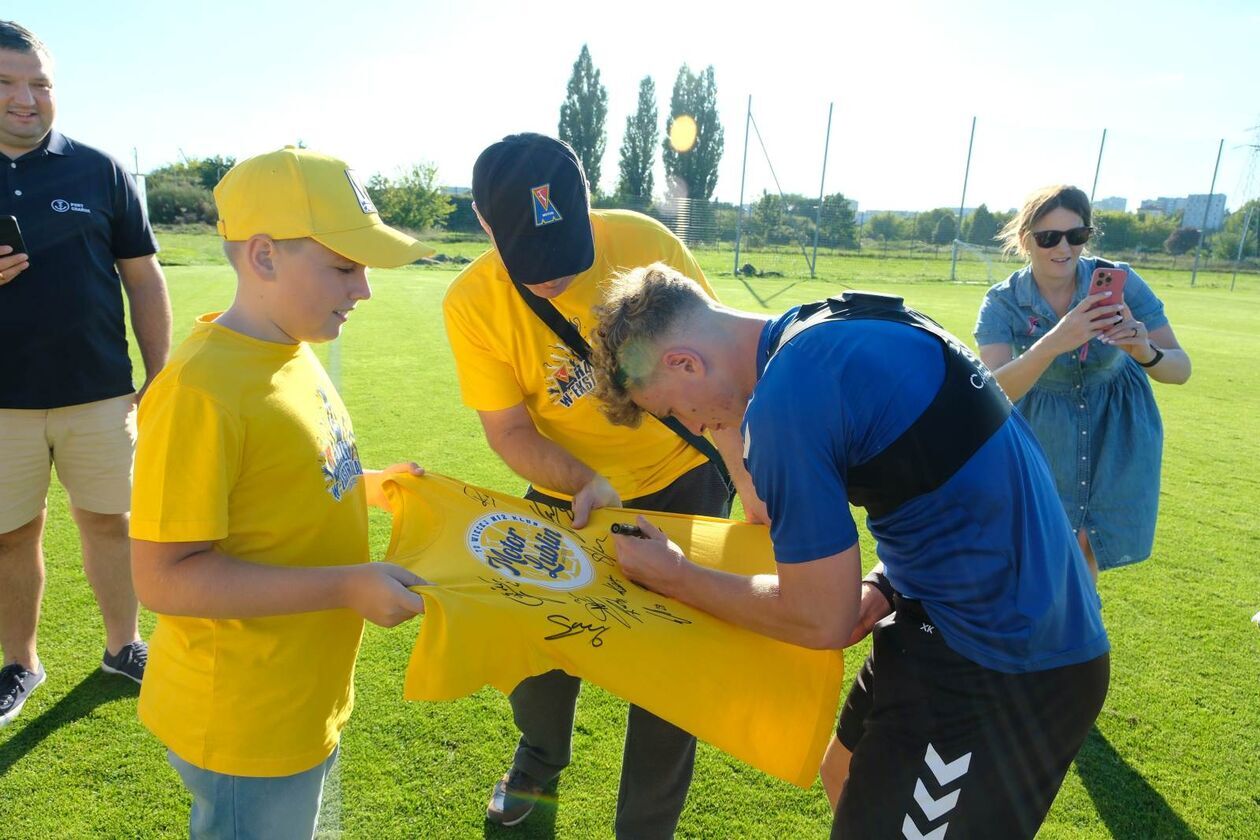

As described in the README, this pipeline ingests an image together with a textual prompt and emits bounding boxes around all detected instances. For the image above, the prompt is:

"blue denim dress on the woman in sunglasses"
[975,257,1168,569]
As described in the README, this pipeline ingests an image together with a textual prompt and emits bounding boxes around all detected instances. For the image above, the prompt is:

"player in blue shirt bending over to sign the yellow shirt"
[595,266,1109,837]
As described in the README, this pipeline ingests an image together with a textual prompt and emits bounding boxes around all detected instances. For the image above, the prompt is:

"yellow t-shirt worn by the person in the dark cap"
[442,210,713,499]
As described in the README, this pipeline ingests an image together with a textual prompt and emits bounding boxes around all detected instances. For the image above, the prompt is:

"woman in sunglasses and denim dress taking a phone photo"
[975,186,1191,581]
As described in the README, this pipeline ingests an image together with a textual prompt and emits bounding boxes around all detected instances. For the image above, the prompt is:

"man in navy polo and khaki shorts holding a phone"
[0,21,170,725]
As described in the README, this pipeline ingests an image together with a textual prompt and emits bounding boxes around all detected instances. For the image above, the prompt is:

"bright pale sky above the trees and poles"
[17,0,1260,210]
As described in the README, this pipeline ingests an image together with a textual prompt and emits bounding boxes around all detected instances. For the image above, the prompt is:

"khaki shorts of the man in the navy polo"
[0,394,136,534]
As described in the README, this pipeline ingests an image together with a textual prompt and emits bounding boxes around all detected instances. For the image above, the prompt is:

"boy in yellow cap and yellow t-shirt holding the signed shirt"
[131,147,432,837]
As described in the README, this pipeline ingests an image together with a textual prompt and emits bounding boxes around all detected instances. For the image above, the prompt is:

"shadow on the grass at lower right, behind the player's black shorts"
[1076,727,1198,840]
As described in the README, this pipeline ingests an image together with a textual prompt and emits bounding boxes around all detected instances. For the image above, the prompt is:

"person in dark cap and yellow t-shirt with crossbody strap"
[442,133,765,837]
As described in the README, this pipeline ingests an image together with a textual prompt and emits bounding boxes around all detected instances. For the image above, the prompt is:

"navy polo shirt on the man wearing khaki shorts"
[0,131,158,408]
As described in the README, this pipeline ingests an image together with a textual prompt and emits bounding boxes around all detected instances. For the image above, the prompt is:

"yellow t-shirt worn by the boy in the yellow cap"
[131,315,368,776]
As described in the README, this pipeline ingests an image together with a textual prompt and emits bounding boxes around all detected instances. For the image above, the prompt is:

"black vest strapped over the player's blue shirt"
[767,292,1012,518]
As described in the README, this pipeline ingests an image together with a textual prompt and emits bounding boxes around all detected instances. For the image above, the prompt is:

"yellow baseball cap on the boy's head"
[214,146,435,268]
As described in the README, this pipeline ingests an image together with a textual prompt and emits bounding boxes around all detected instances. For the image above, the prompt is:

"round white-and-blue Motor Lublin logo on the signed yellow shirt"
[466,513,595,591]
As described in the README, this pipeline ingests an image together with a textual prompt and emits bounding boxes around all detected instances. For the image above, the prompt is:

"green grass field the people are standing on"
[0,234,1260,839]
